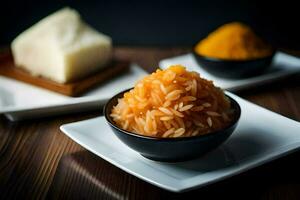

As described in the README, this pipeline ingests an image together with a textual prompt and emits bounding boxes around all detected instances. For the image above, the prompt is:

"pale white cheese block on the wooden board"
[11,8,112,83]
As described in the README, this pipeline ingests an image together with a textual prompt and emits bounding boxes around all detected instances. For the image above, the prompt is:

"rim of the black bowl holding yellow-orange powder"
[192,43,277,63]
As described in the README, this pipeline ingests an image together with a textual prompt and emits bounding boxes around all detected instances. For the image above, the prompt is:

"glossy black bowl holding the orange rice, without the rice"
[104,90,241,162]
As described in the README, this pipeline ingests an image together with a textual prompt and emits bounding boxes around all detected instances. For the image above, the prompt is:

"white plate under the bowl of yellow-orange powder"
[159,52,300,91]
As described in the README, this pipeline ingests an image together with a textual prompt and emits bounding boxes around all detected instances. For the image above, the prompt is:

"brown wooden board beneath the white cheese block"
[0,50,129,97]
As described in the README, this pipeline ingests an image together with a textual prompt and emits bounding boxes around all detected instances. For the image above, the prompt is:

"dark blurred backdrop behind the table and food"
[0,0,300,50]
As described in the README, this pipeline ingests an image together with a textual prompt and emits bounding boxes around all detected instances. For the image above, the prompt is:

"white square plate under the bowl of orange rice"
[61,93,300,192]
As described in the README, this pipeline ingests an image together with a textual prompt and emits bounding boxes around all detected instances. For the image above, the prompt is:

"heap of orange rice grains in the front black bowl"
[110,65,232,137]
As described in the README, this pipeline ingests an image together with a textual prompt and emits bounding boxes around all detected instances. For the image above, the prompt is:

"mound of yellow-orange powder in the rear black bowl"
[195,22,273,60]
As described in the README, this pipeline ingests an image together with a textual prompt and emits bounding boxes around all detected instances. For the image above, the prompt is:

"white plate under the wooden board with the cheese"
[0,64,147,120]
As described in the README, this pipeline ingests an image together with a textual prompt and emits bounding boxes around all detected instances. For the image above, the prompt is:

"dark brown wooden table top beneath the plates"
[0,47,300,199]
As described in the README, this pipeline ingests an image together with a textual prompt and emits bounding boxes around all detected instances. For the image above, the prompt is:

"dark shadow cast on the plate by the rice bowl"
[160,128,281,173]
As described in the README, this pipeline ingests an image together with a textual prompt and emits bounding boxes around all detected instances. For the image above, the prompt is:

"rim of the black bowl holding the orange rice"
[103,88,241,142]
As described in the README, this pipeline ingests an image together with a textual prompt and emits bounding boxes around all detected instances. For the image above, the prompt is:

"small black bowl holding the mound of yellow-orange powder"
[193,48,275,79]
